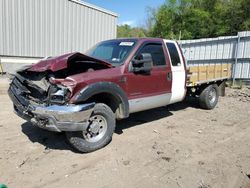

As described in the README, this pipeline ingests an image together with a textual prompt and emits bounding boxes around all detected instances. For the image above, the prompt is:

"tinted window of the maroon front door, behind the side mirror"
[139,43,166,66]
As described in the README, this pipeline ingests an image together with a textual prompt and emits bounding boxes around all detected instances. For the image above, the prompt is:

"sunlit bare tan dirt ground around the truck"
[0,84,250,188]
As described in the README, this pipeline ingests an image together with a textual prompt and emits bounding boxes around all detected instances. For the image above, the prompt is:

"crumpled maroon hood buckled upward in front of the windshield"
[27,52,112,72]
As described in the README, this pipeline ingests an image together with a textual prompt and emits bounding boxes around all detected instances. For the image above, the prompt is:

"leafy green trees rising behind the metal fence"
[148,0,250,39]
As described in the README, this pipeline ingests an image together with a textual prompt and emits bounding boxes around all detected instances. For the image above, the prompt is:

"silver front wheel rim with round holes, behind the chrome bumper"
[83,115,108,142]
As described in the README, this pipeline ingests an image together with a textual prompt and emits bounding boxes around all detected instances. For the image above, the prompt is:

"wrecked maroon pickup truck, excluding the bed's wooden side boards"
[9,38,228,152]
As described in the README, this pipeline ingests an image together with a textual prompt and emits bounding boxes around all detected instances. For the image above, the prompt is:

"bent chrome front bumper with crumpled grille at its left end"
[8,78,95,132]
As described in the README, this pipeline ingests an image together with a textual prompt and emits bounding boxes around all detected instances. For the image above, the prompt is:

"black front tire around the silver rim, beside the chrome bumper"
[65,103,115,153]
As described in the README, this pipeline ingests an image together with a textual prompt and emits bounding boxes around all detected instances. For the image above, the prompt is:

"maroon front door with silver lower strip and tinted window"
[127,41,172,113]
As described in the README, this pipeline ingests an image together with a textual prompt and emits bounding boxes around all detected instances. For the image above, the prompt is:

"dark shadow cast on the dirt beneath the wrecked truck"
[22,99,198,152]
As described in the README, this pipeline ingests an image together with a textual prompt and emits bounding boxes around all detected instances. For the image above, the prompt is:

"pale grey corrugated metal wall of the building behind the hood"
[0,0,117,57]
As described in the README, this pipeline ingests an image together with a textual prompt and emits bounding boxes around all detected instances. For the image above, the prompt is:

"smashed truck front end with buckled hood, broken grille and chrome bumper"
[8,53,111,132]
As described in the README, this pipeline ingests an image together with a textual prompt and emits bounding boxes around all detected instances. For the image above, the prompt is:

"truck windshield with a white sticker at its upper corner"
[86,39,136,66]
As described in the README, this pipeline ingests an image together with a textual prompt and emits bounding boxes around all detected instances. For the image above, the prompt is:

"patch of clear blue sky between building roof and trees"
[84,0,165,27]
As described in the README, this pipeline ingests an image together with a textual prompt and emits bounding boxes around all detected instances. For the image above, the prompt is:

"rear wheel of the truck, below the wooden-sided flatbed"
[199,84,219,110]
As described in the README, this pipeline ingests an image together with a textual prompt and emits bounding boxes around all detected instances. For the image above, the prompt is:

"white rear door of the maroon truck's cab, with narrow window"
[164,40,186,104]
